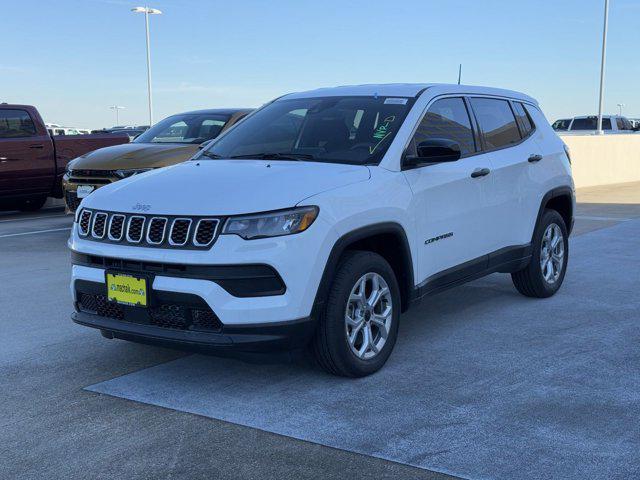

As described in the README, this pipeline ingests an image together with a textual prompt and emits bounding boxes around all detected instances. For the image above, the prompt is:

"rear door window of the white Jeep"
[471,97,521,150]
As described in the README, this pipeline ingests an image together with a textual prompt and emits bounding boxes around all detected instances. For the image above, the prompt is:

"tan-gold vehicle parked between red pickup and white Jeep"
[63,108,251,212]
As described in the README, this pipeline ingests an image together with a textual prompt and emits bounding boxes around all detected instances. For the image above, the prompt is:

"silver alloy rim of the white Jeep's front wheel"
[344,272,393,360]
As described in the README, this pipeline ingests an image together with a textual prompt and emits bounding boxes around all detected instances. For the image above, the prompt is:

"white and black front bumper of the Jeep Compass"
[69,204,337,350]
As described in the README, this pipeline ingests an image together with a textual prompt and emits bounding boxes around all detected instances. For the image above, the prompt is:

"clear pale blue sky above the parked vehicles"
[0,0,640,128]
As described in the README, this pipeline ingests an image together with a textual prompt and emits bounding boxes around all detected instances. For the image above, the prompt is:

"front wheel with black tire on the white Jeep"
[311,251,401,377]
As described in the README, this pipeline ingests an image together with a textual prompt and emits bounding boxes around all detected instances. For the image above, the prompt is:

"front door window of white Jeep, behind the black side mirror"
[409,97,476,156]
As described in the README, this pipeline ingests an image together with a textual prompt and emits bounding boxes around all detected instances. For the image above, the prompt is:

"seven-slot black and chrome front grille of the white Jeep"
[78,208,222,249]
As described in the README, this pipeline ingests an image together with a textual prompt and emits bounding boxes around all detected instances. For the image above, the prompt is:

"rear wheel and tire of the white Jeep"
[511,210,569,298]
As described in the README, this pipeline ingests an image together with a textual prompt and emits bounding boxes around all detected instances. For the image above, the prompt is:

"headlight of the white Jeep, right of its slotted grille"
[222,207,319,240]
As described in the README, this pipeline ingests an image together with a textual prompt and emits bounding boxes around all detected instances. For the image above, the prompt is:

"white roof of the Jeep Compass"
[281,83,538,103]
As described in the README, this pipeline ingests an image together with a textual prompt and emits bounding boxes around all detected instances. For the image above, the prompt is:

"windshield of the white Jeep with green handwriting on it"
[199,97,413,165]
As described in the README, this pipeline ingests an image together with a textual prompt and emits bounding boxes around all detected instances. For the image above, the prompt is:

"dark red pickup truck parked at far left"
[0,103,129,211]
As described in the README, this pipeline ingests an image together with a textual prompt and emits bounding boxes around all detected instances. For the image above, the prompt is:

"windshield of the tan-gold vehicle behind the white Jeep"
[134,113,229,143]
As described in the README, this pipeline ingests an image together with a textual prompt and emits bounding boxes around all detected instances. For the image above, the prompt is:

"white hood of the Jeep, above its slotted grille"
[82,160,370,215]
